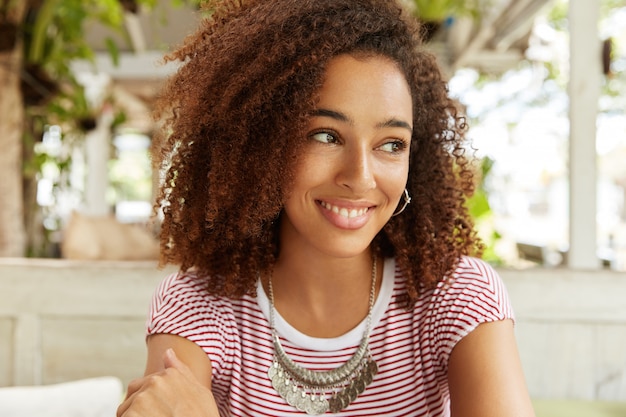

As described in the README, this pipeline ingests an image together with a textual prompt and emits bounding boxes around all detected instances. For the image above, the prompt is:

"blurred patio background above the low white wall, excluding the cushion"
[0,0,626,270]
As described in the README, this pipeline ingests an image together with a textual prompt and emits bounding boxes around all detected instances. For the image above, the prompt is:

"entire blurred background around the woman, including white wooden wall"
[0,0,626,417]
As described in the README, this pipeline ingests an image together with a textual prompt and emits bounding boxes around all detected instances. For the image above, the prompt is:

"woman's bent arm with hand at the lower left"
[117,334,219,417]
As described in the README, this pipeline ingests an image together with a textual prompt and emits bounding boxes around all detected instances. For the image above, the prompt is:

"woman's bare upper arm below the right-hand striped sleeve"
[448,320,535,417]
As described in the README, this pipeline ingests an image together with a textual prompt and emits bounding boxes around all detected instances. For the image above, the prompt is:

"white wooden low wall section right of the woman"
[500,269,626,401]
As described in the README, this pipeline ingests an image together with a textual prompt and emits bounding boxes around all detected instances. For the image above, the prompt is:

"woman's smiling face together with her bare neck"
[272,55,412,337]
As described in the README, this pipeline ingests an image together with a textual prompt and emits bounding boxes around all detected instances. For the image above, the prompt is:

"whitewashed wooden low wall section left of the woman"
[0,259,167,386]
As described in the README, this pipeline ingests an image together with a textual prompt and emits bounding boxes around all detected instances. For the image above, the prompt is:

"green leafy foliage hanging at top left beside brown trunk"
[21,0,171,140]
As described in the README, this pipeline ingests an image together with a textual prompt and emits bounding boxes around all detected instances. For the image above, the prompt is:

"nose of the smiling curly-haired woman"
[337,147,376,193]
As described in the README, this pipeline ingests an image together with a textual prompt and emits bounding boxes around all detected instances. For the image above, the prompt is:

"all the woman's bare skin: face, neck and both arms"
[118,54,534,417]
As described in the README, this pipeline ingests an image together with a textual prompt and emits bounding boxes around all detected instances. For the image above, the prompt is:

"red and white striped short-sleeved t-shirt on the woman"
[147,258,513,417]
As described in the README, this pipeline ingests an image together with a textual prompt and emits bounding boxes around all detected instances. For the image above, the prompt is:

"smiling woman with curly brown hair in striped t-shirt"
[118,0,533,417]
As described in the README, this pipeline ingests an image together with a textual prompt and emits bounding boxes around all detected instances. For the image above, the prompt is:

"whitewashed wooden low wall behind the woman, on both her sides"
[0,259,626,401]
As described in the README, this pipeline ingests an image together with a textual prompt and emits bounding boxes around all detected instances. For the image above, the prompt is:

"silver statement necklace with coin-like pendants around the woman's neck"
[267,257,378,415]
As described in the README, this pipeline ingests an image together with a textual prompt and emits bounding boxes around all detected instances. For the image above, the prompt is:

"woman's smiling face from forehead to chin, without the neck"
[281,55,413,257]
